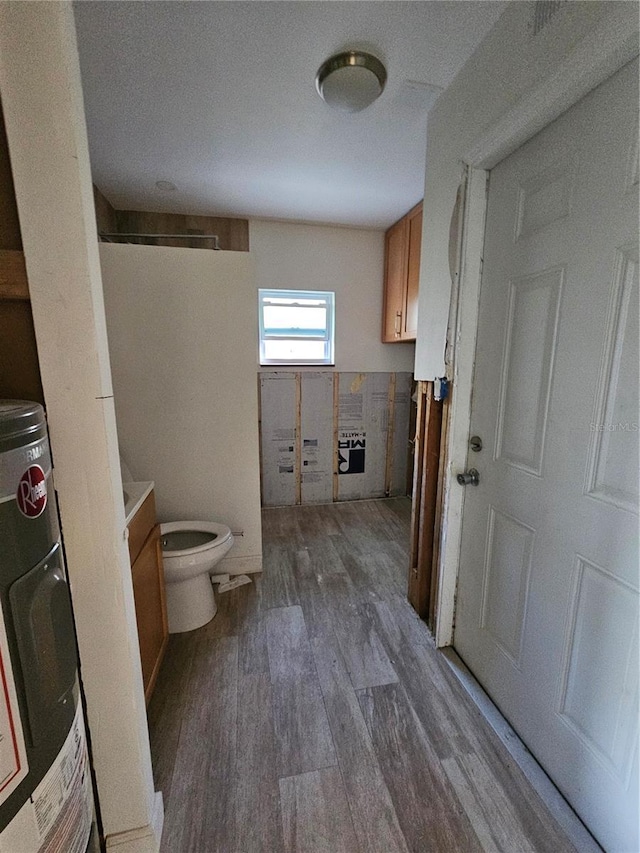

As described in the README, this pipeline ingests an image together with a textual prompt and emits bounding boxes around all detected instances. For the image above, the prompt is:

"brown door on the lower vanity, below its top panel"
[131,527,168,702]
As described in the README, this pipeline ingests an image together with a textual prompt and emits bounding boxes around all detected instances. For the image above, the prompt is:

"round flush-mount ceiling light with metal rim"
[316,50,387,113]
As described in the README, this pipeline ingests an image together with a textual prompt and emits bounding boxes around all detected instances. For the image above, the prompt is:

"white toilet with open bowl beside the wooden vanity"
[160,521,233,634]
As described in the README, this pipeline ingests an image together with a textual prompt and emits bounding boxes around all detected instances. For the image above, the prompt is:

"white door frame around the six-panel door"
[434,12,639,647]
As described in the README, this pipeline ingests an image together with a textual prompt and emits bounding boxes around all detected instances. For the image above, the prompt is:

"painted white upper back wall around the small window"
[249,219,415,373]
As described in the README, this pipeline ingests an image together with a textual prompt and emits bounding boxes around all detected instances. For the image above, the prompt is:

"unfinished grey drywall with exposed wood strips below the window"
[259,371,412,506]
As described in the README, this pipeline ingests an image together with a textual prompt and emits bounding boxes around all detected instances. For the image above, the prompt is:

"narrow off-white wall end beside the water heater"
[0,3,162,853]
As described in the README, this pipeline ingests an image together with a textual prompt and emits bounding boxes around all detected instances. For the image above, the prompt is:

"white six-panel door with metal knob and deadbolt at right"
[455,61,640,853]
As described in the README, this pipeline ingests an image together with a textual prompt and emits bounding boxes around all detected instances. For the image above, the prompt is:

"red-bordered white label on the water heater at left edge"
[0,608,29,804]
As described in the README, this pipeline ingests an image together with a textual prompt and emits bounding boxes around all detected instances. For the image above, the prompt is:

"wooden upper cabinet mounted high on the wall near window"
[382,202,422,343]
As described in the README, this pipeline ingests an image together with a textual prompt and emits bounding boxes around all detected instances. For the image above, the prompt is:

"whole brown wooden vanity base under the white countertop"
[129,491,169,704]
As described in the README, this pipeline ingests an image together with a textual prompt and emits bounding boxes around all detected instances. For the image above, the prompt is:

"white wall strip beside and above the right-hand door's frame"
[415,2,638,380]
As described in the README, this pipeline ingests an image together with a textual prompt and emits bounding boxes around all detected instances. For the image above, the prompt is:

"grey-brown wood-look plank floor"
[149,498,575,853]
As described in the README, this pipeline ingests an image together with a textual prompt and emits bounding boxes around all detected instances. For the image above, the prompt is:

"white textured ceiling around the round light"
[75,0,505,228]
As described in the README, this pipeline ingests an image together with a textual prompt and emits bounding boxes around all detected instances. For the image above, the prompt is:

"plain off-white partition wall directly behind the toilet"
[100,244,262,573]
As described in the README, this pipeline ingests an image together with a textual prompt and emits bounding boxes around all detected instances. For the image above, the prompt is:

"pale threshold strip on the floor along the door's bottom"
[440,646,603,853]
